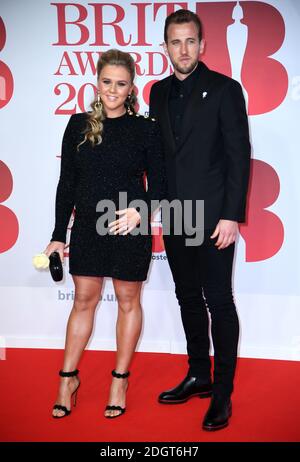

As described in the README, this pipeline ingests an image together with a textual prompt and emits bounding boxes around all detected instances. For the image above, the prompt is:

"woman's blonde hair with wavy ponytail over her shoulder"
[77,49,137,150]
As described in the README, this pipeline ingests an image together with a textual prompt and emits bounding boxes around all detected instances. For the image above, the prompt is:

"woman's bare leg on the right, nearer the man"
[105,279,142,416]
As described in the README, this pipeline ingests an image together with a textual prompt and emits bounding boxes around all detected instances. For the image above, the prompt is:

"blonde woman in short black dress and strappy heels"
[45,50,165,418]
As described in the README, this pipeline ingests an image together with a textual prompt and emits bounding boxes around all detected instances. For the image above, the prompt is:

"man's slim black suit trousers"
[164,230,239,396]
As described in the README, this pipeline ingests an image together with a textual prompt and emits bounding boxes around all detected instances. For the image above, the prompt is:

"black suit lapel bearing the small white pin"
[177,62,211,151]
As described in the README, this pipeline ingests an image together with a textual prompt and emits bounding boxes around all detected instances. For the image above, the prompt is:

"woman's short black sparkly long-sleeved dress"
[51,113,166,281]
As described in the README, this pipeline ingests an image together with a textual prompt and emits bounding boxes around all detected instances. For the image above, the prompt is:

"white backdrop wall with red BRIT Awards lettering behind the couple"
[0,0,300,360]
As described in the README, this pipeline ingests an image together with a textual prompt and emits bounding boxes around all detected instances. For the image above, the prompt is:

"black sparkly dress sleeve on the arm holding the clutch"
[50,115,76,243]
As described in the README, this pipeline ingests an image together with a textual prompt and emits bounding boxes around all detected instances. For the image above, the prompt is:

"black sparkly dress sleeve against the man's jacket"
[146,120,167,211]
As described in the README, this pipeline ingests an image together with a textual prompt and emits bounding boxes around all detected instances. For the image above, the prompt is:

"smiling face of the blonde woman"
[98,64,133,117]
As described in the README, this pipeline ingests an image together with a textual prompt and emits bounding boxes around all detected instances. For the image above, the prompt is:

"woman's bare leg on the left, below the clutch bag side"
[53,276,103,417]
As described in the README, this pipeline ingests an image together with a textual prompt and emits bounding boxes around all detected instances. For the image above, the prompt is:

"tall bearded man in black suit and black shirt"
[150,10,250,430]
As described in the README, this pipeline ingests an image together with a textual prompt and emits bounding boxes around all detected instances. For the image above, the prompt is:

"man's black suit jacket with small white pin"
[150,62,251,229]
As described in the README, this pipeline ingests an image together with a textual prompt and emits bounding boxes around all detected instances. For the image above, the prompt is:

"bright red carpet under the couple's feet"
[0,348,300,442]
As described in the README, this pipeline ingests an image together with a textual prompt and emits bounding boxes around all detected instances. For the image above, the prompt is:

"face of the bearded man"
[164,22,204,79]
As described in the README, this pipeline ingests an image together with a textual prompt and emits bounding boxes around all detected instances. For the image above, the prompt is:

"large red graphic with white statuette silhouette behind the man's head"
[196,1,288,115]
